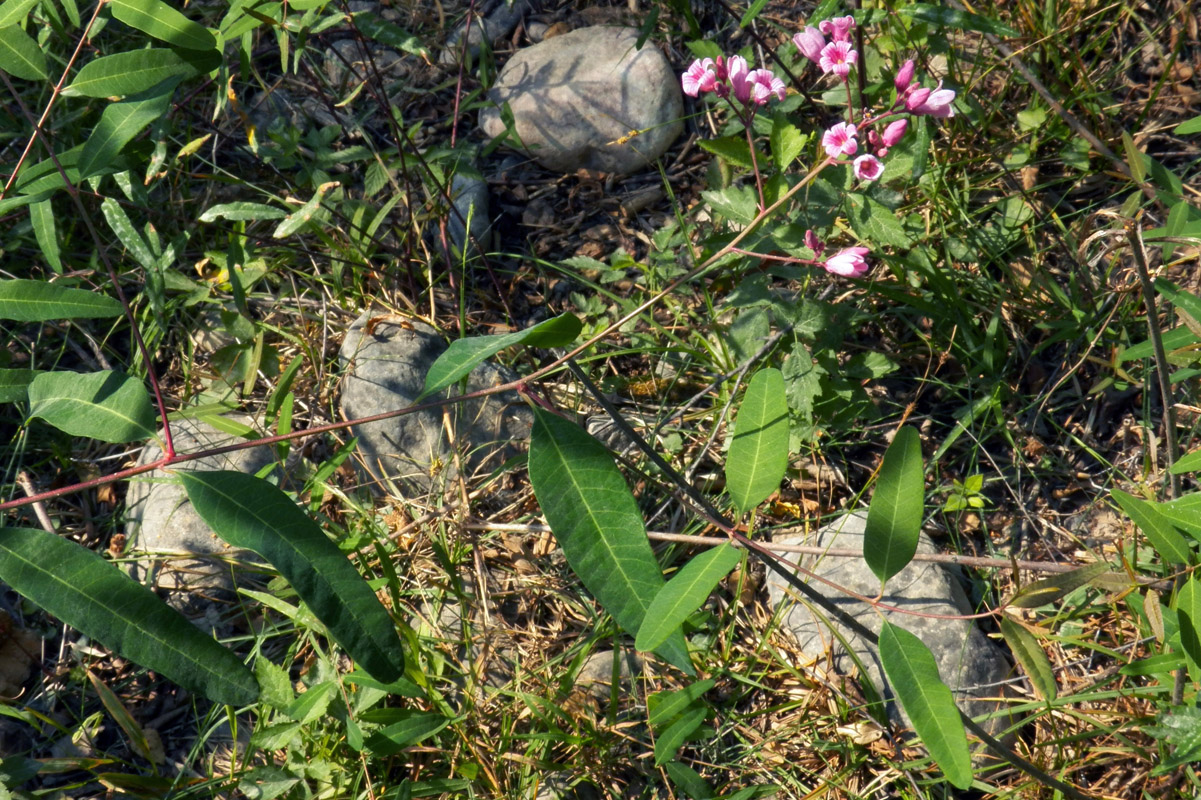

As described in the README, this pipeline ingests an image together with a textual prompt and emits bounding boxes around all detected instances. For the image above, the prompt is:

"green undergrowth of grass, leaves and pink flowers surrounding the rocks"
[0,0,1201,800]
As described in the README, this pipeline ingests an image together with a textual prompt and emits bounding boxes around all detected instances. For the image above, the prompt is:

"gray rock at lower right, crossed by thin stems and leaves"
[767,512,1012,735]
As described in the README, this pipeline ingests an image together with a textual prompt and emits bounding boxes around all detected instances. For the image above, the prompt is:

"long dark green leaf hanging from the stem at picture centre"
[530,407,693,675]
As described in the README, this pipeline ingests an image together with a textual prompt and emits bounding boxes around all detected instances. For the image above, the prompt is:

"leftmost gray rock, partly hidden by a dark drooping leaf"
[125,414,276,627]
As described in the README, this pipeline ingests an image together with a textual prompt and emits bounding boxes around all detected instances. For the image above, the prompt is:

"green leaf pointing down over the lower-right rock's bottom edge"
[879,622,972,789]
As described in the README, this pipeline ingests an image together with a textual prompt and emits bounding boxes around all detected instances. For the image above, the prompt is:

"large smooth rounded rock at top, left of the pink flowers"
[479,26,683,173]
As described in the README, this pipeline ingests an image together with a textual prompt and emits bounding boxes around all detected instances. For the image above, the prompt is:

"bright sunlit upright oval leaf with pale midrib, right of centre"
[725,369,789,514]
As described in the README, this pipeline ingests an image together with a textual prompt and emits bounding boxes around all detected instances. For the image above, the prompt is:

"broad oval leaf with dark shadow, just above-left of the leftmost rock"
[29,370,155,443]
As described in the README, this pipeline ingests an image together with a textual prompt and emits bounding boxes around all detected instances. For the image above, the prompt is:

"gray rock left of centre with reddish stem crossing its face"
[341,309,533,491]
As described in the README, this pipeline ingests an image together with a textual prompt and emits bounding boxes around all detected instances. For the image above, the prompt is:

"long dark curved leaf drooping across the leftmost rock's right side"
[179,471,405,682]
